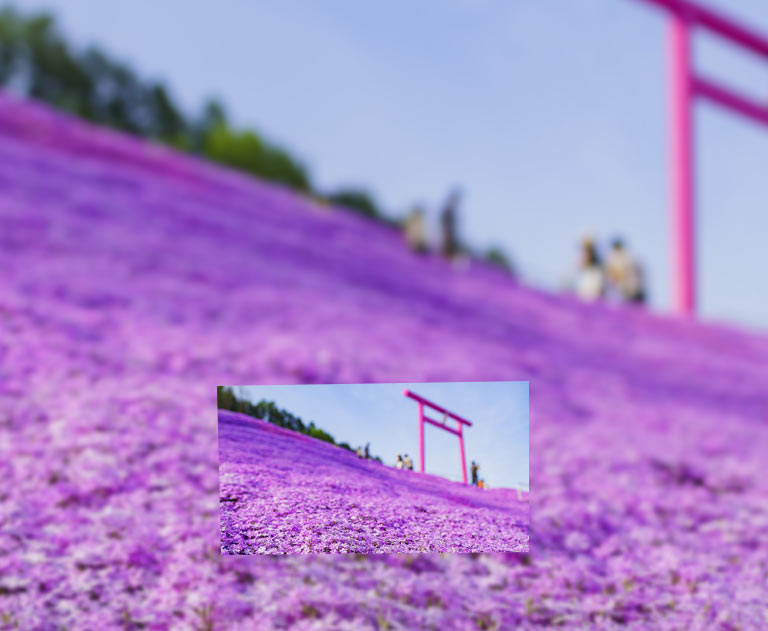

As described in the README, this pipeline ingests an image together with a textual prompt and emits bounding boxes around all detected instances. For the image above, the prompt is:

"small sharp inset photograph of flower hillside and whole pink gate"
[217,381,529,555]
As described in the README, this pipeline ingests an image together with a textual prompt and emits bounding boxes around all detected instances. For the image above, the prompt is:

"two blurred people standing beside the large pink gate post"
[574,237,646,304]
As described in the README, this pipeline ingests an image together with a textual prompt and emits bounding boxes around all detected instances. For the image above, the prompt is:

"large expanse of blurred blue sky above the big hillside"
[16,0,768,329]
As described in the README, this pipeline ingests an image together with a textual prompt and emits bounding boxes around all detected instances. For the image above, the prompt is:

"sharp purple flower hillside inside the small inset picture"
[219,410,528,554]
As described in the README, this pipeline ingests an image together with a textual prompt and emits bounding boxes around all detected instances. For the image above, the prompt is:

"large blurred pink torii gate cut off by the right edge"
[632,0,768,316]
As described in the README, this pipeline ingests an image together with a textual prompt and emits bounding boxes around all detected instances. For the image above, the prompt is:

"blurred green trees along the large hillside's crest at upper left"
[0,8,510,269]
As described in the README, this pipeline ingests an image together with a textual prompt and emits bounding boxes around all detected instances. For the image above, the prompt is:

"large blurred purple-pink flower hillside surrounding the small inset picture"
[0,96,768,631]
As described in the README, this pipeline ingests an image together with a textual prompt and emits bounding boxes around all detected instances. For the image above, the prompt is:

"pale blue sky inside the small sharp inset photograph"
[240,381,529,489]
